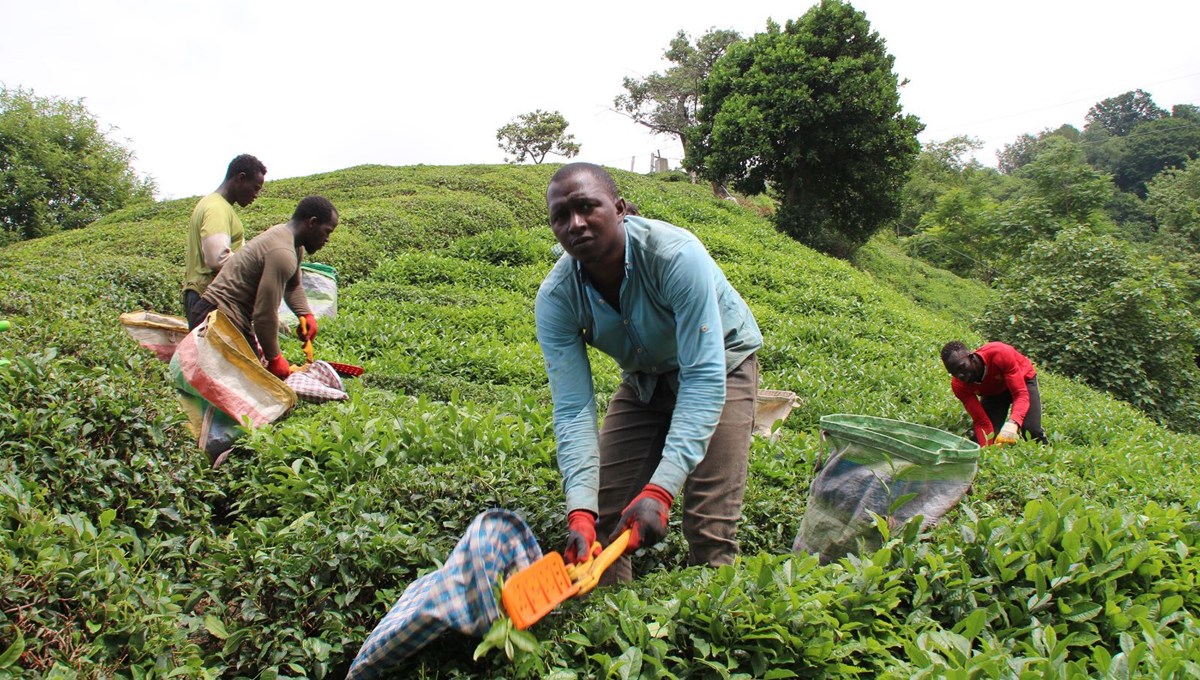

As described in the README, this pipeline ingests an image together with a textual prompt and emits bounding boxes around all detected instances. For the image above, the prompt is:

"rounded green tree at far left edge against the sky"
[0,88,155,243]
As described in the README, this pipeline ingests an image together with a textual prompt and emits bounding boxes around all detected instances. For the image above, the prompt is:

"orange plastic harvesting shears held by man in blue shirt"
[500,529,629,631]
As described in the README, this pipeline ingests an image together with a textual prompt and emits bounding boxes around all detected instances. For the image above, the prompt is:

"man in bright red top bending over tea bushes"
[942,341,1046,446]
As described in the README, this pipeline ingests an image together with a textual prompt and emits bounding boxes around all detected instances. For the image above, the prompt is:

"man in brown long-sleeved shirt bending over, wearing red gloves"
[197,195,337,380]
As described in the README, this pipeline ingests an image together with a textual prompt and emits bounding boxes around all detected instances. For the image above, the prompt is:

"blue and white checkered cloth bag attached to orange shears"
[347,509,541,680]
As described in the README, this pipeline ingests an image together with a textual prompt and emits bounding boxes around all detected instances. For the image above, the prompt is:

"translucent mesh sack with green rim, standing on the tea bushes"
[792,414,979,562]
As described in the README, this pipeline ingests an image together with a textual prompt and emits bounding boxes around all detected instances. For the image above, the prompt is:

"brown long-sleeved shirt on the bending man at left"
[202,224,312,359]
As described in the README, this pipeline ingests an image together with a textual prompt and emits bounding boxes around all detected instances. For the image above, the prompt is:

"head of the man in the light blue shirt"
[546,171,625,266]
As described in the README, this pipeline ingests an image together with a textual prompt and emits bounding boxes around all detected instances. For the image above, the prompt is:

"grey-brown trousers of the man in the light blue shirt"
[596,354,758,584]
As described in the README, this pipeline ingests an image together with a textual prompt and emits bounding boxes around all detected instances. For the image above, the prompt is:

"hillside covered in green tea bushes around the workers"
[0,166,1200,678]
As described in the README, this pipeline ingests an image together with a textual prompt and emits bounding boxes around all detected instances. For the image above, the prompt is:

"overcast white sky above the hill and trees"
[0,0,1200,198]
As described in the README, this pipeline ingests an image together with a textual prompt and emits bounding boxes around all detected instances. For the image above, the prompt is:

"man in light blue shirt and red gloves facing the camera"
[535,163,762,582]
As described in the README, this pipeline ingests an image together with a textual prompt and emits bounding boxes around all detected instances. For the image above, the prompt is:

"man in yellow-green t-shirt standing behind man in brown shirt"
[184,154,266,329]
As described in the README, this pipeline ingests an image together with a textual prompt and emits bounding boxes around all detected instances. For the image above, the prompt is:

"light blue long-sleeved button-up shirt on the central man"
[534,217,762,512]
